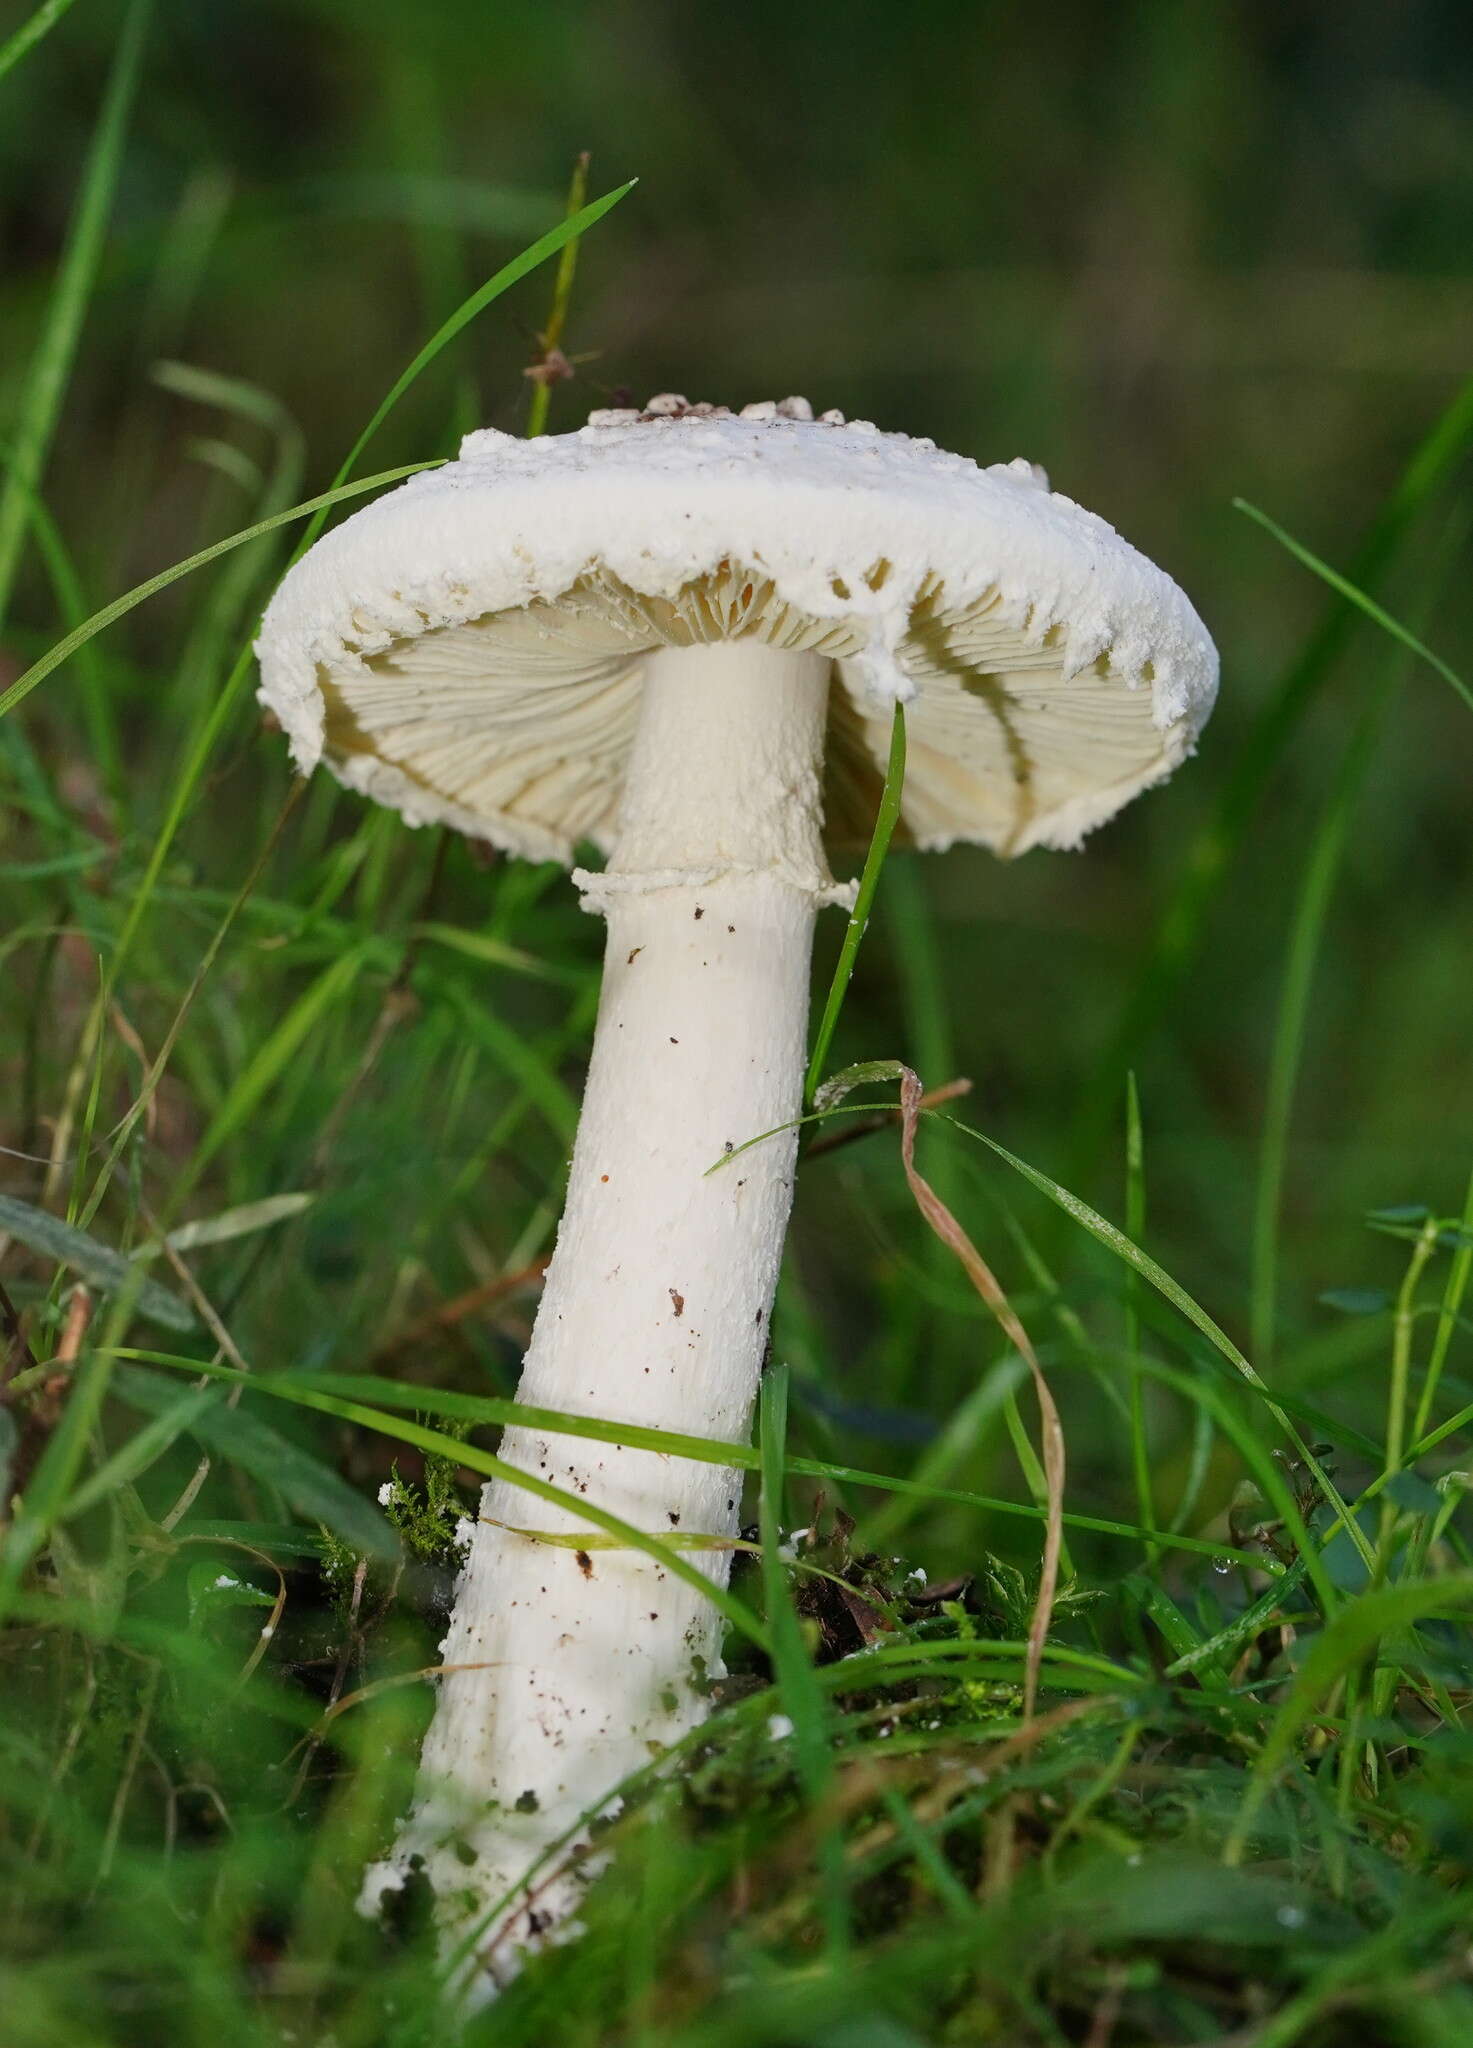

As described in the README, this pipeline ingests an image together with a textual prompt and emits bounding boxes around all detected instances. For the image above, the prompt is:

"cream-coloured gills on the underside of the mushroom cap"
[318,561,1182,854]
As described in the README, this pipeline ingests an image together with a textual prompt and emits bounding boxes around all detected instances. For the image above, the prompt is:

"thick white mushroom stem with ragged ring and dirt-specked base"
[369,639,840,1991]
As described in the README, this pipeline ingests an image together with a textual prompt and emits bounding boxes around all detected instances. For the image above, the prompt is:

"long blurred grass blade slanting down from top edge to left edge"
[0,0,152,621]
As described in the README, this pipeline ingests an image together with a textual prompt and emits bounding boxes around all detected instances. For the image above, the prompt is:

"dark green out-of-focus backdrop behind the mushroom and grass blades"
[0,0,1473,1540]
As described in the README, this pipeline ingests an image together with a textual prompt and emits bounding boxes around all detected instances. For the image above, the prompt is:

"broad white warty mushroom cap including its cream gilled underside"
[256,397,1217,862]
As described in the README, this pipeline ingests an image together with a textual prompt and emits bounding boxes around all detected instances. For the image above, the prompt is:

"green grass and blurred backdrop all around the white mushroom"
[0,0,1473,2048]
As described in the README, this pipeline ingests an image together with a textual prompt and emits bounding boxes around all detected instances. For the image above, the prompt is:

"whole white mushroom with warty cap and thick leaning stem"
[258,395,1217,1980]
